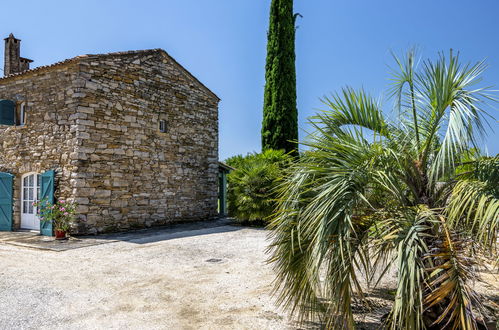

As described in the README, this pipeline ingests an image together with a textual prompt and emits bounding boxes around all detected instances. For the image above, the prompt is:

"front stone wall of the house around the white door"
[0,65,78,229]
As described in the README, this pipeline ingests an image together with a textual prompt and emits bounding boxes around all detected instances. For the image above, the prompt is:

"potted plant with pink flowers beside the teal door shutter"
[33,199,76,239]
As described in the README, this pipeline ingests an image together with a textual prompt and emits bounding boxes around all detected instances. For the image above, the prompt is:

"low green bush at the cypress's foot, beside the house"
[226,150,291,222]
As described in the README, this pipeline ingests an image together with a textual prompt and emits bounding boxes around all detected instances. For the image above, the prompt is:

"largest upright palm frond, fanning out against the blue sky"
[417,52,495,182]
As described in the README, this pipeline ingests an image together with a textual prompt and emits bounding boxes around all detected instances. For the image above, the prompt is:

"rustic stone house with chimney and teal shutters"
[0,34,219,235]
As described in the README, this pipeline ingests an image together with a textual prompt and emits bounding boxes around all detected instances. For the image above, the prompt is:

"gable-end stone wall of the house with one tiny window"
[72,50,218,233]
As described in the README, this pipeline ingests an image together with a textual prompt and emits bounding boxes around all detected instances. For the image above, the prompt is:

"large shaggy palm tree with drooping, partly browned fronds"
[270,50,499,329]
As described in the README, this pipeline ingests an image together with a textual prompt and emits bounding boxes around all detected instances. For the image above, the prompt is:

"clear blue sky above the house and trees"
[0,0,499,159]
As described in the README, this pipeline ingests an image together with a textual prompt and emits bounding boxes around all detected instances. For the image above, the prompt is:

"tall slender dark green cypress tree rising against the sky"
[262,0,298,155]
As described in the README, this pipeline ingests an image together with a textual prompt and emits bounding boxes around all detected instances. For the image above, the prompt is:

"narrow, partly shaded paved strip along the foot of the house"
[0,218,244,252]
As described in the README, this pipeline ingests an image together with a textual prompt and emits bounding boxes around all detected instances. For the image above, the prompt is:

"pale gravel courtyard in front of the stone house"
[0,225,498,330]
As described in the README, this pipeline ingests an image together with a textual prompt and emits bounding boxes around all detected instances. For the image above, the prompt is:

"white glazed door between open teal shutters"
[21,173,40,230]
